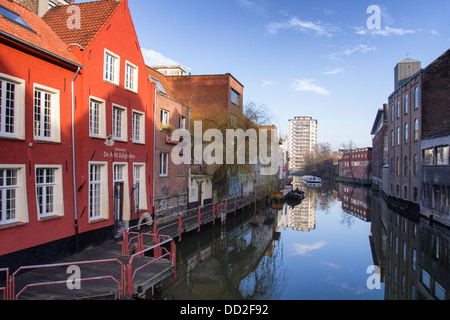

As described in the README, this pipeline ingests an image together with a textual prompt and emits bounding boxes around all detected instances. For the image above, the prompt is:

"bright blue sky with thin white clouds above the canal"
[124,0,450,149]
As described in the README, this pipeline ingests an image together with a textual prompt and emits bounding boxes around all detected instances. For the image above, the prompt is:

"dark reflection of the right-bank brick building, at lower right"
[371,191,450,300]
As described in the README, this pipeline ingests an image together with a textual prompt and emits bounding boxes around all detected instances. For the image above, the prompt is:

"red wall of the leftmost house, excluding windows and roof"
[0,44,75,256]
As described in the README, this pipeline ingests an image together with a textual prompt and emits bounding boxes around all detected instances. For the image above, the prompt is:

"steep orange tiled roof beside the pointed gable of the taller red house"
[42,0,120,47]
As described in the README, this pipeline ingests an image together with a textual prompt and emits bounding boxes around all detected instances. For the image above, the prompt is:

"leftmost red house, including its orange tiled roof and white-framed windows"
[0,0,82,265]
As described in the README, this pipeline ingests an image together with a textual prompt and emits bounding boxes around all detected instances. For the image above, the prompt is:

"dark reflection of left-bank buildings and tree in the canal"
[156,208,279,300]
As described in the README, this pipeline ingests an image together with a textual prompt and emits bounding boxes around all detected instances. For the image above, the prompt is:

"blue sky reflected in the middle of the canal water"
[239,185,384,300]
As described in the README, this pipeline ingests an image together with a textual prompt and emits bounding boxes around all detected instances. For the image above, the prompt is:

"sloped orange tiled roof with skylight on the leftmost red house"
[0,0,80,65]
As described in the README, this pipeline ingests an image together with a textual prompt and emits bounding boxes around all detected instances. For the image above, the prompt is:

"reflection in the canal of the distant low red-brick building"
[339,183,372,221]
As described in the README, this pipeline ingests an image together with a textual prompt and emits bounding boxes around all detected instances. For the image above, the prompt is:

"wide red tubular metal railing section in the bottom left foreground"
[9,259,126,300]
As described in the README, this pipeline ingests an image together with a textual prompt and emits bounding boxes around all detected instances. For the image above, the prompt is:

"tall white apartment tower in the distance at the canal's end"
[289,117,317,172]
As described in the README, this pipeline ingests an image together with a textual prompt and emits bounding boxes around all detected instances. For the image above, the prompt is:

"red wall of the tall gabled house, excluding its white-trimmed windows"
[68,2,154,233]
